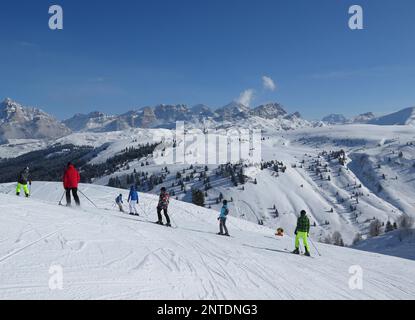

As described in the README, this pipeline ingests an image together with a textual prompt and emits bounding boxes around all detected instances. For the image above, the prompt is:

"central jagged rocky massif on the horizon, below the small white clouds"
[64,102,310,132]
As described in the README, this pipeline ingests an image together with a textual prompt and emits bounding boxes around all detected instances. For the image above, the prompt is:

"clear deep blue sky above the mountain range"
[0,0,415,119]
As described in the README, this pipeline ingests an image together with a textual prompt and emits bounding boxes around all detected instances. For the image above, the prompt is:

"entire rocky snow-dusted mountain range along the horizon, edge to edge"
[0,98,415,143]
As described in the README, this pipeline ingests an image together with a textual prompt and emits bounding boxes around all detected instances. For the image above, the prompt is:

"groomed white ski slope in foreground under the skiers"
[0,182,415,300]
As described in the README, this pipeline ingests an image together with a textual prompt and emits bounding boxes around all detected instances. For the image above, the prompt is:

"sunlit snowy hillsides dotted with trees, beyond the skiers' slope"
[0,124,415,251]
